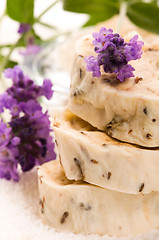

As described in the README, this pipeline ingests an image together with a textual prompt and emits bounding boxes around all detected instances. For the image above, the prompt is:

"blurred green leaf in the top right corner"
[127,1,159,33]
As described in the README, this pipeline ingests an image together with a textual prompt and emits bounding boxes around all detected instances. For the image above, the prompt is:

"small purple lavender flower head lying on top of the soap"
[85,28,144,82]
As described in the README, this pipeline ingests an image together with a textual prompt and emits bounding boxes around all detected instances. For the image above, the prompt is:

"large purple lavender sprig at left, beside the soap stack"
[0,66,56,181]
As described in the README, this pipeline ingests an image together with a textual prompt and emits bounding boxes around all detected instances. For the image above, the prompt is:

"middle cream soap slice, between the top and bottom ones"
[53,109,159,194]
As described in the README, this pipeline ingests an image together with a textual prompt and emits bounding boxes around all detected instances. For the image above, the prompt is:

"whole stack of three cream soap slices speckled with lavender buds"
[38,32,159,237]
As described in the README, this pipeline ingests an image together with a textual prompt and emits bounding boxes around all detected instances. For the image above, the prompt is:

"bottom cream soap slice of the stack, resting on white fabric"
[38,160,159,237]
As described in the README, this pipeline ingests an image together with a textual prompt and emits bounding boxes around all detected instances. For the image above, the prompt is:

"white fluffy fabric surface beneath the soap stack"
[0,165,159,240]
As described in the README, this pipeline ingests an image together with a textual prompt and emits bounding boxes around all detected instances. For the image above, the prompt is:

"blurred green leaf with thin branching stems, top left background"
[0,0,60,76]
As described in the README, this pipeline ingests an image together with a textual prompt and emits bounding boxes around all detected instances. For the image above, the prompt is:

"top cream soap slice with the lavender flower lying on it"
[69,35,159,147]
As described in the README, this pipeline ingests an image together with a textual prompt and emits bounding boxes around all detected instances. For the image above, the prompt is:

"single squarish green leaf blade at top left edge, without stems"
[7,0,34,24]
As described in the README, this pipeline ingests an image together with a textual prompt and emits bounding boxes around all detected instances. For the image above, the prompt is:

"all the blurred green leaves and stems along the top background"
[0,0,159,75]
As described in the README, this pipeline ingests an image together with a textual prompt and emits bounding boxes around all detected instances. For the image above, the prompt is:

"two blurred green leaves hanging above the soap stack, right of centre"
[64,0,159,33]
